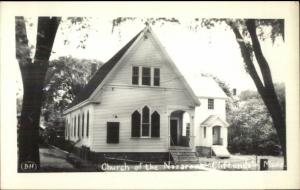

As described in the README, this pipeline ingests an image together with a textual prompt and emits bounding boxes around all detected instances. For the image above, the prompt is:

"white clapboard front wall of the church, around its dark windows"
[91,34,193,152]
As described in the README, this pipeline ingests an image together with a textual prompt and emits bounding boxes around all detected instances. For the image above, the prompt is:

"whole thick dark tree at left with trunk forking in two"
[15,17,61,171]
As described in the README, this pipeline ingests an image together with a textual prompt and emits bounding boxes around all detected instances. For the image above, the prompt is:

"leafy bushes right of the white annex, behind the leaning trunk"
[227,84,285,155]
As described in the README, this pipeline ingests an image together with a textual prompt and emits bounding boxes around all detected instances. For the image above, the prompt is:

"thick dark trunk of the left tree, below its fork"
[18,63,47,172]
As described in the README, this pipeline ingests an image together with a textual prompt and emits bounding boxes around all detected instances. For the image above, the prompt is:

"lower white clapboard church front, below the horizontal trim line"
[93,86,191,152]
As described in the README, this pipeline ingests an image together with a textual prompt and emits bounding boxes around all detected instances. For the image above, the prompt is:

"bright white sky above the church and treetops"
[16,17,286,95]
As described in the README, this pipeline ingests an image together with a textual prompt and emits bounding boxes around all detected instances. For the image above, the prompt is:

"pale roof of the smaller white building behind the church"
[188,76,228,99]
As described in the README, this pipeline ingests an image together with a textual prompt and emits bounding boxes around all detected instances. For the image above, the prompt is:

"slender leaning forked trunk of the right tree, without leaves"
[229,19,287,170]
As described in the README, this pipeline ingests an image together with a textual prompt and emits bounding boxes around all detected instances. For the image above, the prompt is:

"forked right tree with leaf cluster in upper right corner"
[227,19,287,169]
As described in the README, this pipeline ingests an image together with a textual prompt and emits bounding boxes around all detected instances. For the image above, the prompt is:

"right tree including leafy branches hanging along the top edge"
[116,18,287,170]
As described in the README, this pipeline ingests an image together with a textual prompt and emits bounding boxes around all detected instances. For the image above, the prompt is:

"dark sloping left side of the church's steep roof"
[68,30,143,109]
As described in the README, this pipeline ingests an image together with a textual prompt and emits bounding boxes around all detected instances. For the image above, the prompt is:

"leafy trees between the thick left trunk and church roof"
[43,57,103,119]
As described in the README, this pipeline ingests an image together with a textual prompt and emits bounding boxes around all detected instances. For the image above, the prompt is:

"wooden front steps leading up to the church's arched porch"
[169,146,199,165]
